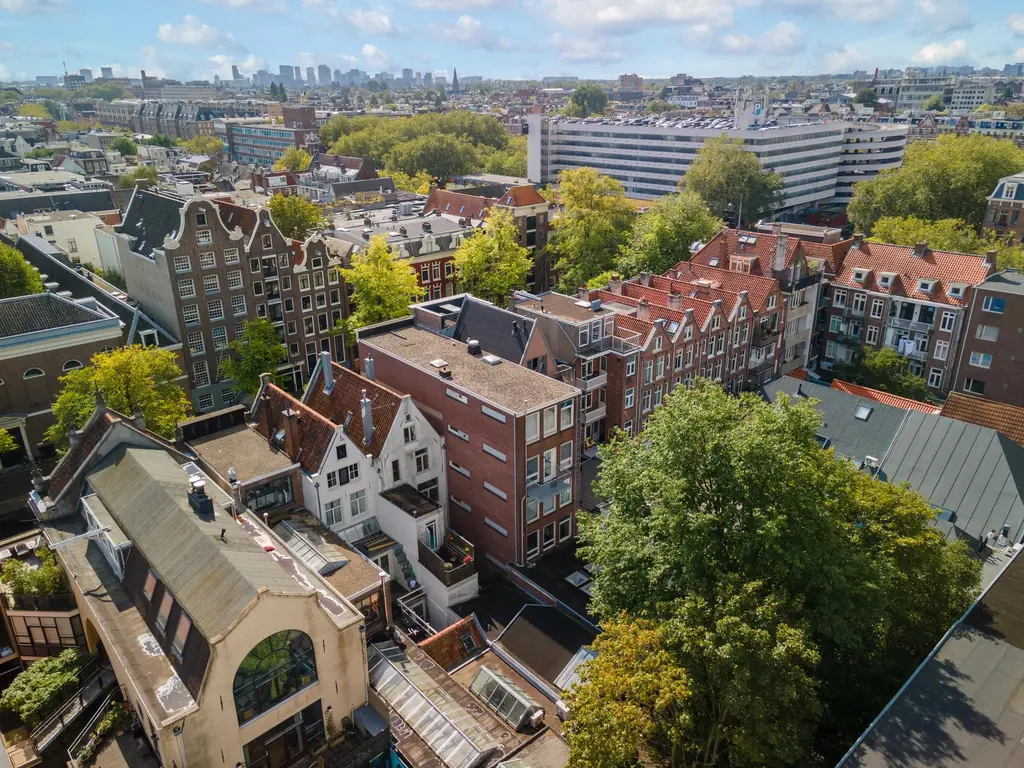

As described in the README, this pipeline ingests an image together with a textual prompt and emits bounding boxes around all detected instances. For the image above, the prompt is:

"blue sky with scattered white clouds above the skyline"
[0,0,1024,80]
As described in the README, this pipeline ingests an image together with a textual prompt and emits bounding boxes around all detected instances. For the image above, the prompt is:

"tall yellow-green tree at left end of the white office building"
[548,168,636,293]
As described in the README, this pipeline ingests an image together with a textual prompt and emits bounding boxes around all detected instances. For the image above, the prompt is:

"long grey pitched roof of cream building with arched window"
[87,444,306,639]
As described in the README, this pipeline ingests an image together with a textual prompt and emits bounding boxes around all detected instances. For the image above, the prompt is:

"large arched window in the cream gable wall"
[232,630,316,725]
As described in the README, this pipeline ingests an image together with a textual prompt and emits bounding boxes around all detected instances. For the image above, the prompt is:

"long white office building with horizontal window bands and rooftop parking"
[526,109,906,210]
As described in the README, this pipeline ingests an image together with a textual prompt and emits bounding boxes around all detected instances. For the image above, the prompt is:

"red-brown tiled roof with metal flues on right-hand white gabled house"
[304,361,401,458]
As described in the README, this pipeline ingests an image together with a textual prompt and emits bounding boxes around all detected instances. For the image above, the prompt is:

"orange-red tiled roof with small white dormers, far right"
[835,241,991,306]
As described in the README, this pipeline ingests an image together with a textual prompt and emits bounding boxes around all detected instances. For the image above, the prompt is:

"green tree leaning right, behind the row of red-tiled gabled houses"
[618,190,725,276]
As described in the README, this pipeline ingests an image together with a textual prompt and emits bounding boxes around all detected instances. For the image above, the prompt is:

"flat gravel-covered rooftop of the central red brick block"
[358,319,579,415]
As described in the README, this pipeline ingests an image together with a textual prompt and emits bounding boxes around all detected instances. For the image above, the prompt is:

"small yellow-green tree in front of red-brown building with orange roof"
[454,209,530,306]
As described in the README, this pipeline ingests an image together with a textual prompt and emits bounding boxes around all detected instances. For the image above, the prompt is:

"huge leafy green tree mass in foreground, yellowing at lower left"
[567,381,980,768]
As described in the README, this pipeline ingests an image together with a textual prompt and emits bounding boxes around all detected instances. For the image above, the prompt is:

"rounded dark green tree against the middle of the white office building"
[679,136,783,226]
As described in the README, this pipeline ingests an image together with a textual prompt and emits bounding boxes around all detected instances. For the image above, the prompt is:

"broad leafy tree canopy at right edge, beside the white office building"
[847,133,1024,234]
